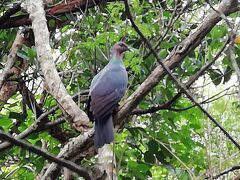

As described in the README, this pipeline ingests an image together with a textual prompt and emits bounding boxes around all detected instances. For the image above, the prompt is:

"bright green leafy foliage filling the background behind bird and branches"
[0,0,240,180]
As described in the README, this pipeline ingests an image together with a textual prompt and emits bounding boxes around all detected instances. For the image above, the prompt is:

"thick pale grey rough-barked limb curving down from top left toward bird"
[21,0,89,131]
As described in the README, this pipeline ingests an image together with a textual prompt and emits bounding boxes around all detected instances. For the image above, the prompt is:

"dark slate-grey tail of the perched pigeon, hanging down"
[94,116,114,148]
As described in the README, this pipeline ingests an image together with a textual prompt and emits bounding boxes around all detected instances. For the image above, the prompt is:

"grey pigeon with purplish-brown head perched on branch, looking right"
[87,40,130,148]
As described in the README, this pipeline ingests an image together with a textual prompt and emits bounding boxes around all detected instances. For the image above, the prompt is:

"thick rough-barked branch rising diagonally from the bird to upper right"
[115,0,238,124]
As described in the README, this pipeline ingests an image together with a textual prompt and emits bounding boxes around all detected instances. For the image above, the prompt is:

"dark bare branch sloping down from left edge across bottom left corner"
[0,130,91,179]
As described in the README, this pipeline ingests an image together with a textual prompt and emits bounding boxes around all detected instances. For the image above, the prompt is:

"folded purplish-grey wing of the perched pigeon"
[90,73,126,119]
